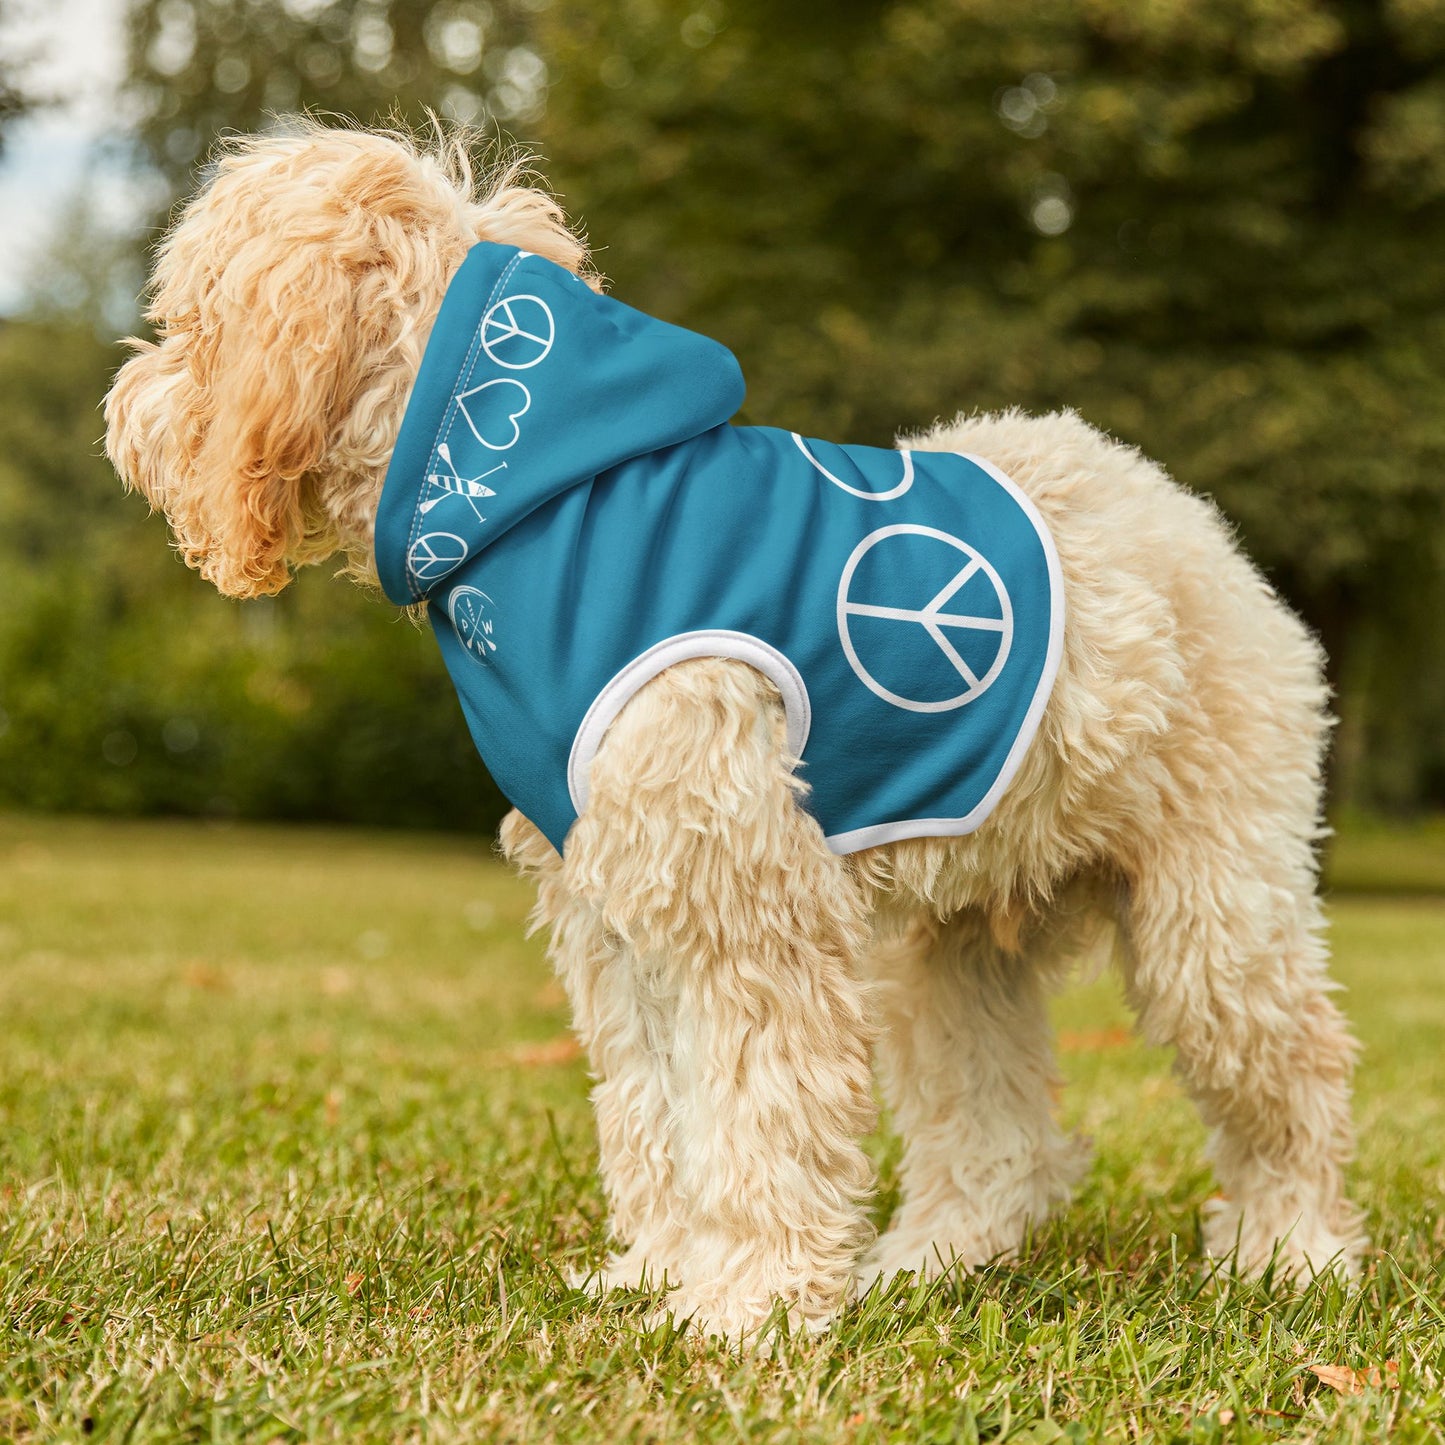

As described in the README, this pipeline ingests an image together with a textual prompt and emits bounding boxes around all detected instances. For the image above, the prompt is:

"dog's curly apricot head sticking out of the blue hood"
[105,123,587,597]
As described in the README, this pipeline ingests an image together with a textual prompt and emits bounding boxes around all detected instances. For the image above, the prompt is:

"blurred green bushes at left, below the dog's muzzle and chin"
[0,322,506,831]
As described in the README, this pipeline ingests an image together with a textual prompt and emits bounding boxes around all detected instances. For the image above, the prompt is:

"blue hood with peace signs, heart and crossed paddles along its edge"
[376,241,744,607]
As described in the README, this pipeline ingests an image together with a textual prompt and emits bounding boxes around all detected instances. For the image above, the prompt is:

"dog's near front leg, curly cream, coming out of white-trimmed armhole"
[564,660,874,1340]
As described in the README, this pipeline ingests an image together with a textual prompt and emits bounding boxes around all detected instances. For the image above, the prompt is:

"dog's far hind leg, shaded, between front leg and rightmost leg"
[861,910,1088,1283]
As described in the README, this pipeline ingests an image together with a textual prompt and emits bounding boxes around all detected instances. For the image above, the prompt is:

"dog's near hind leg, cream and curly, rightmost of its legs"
[1126,827,1364,1274]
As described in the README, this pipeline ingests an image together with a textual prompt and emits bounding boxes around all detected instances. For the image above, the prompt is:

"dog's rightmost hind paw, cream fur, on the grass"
[1204,1199,1368,1282]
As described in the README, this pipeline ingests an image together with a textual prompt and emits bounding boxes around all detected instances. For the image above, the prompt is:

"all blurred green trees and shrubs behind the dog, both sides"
[0,0,1445,827]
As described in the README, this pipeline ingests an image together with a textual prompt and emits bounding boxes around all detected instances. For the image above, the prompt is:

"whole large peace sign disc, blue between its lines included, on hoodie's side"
[838,523,1013,712]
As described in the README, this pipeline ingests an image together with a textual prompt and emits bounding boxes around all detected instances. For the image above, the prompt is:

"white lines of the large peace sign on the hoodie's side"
[838,523,1013,712]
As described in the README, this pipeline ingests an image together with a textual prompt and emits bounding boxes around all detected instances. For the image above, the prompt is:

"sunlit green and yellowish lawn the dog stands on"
[0,818,1445,1445]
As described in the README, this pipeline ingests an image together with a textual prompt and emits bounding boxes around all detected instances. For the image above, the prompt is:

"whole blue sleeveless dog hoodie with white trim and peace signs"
[376,241,1064,853]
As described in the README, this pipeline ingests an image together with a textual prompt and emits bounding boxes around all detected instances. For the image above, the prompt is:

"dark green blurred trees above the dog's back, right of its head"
[538,0,1445,799]
